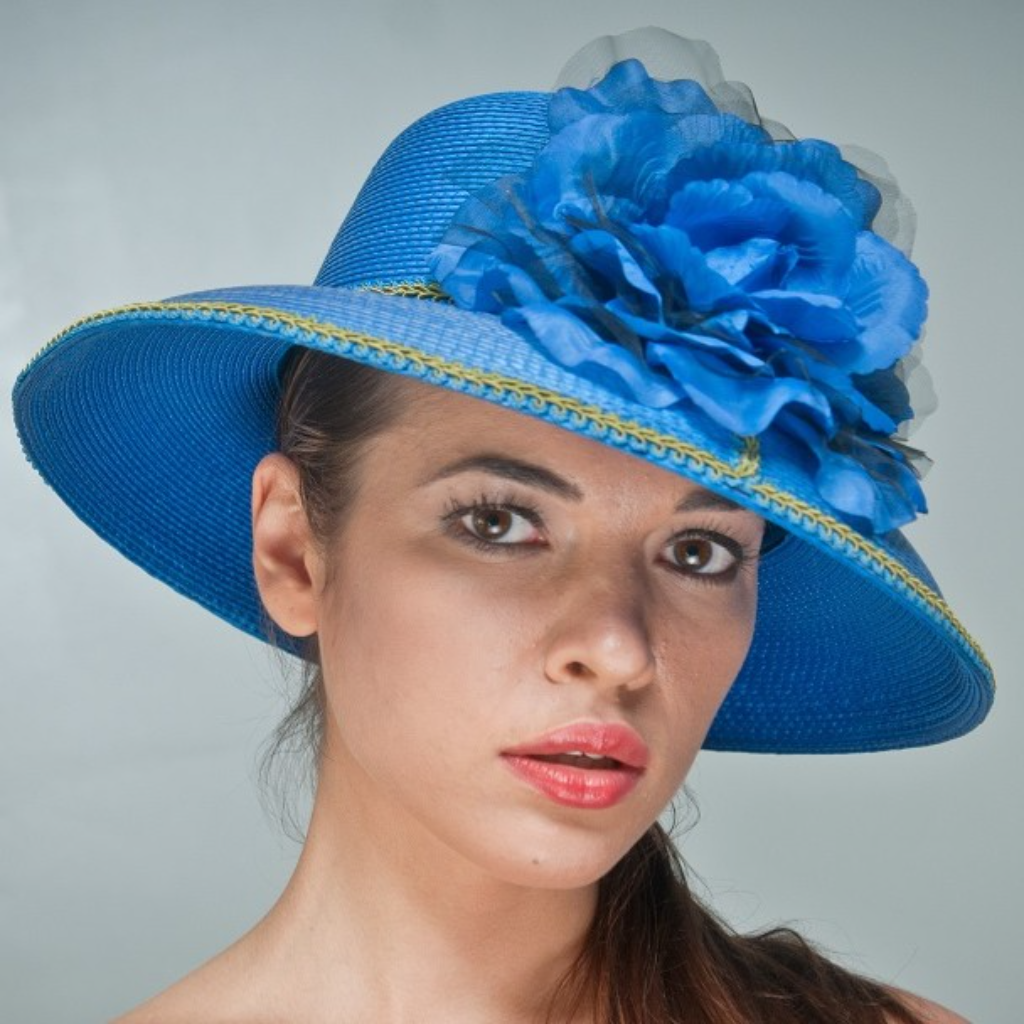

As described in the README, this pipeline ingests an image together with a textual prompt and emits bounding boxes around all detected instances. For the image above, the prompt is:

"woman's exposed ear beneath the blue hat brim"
[252,452,324,637]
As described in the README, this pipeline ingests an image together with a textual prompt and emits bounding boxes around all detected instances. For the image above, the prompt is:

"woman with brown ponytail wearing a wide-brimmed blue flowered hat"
[15,28,991,1021]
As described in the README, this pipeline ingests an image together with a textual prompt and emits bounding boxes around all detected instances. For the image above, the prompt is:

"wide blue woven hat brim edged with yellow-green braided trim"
[14,286,994,753]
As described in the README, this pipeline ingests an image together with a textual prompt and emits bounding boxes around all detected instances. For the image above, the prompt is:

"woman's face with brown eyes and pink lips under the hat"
[303,382,763,887]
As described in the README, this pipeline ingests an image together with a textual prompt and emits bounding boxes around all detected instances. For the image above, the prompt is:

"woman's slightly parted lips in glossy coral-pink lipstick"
[502,722,648,810]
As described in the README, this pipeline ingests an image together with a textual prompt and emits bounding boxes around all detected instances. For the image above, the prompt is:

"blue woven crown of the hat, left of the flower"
[313,92,550,288]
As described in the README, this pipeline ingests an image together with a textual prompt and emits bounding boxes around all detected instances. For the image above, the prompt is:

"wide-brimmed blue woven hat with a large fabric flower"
[13,37,993,753]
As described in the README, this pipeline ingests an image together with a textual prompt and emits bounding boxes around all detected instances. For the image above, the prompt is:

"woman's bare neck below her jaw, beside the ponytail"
[228,729,597,1024]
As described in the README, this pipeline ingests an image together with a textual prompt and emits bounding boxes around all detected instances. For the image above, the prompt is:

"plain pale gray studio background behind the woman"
[0,0,1024,1024]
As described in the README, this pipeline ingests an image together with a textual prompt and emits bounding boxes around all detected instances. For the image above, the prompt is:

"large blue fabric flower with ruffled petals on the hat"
[432,60,928,532]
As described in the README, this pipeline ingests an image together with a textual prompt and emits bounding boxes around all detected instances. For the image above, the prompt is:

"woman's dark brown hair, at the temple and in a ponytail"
[261,349,922,1024]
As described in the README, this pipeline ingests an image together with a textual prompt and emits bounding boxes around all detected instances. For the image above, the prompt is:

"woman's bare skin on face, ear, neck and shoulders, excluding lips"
[112,382,962,1024]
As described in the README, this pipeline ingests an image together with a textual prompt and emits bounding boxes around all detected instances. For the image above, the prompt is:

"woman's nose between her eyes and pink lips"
[545,578,655,692]
